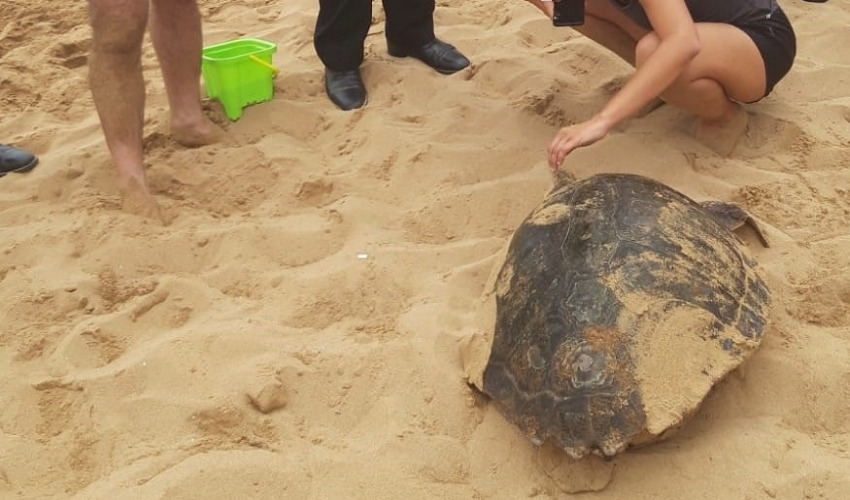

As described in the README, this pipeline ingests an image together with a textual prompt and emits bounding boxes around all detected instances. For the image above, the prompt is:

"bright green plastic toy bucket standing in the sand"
[201,38,277,121]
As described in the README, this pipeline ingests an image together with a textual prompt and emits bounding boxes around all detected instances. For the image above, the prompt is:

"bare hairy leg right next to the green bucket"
[151,0,217,147]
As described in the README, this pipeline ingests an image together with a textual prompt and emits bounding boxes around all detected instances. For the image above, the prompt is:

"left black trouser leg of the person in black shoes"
[313,0,370,71]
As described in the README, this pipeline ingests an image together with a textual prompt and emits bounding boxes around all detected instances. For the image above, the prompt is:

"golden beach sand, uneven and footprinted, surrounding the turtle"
[0,0,850,500]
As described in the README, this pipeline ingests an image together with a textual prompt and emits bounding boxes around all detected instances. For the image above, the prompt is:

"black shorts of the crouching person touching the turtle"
[736,5,797,97]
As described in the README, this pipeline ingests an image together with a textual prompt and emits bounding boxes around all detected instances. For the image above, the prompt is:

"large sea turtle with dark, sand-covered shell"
[464,174,770,458]
